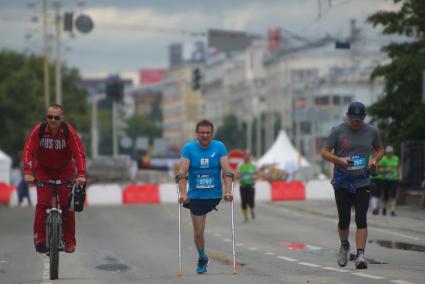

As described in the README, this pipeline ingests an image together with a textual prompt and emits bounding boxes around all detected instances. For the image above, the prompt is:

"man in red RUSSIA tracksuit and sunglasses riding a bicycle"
[24,104,86,253]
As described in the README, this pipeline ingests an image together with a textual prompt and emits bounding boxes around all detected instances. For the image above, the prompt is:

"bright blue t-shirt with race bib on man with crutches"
[181,140,227,199]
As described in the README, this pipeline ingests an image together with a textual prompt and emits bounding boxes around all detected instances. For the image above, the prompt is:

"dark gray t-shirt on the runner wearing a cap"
[324,122,382,188]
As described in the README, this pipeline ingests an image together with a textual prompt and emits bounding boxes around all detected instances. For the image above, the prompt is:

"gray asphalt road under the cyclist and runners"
[0,201,425,284]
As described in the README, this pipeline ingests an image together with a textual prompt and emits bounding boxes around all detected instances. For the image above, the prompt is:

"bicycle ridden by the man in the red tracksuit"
[35,179,74,280]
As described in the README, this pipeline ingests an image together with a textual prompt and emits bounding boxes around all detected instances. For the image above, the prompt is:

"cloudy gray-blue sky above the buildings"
[0,0,397,80]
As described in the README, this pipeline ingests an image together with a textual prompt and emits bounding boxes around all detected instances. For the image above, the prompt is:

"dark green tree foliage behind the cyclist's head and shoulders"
[0,51,89,163]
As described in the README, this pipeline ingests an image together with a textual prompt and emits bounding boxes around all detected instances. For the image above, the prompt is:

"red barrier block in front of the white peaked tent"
[272,181,305,201]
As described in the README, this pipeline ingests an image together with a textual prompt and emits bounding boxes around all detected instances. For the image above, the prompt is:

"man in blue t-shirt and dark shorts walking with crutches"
[177,119,234,273]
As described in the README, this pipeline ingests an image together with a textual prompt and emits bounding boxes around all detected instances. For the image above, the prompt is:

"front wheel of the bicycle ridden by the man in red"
[49,213,60,280]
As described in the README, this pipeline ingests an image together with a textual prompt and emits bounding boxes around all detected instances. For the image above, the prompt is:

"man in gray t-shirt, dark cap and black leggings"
[322,102,384,269]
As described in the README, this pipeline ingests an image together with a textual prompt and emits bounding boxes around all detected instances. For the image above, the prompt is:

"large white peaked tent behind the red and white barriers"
[257,130,310,173]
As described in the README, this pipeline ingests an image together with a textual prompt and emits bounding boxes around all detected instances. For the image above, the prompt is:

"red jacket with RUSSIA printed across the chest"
[24,123,86,180]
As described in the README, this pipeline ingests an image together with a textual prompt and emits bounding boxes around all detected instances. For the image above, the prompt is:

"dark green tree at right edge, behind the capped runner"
[367,0,425,150]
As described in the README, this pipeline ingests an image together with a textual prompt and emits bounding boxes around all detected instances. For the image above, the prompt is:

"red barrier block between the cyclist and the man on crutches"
[122,184,159,204]
